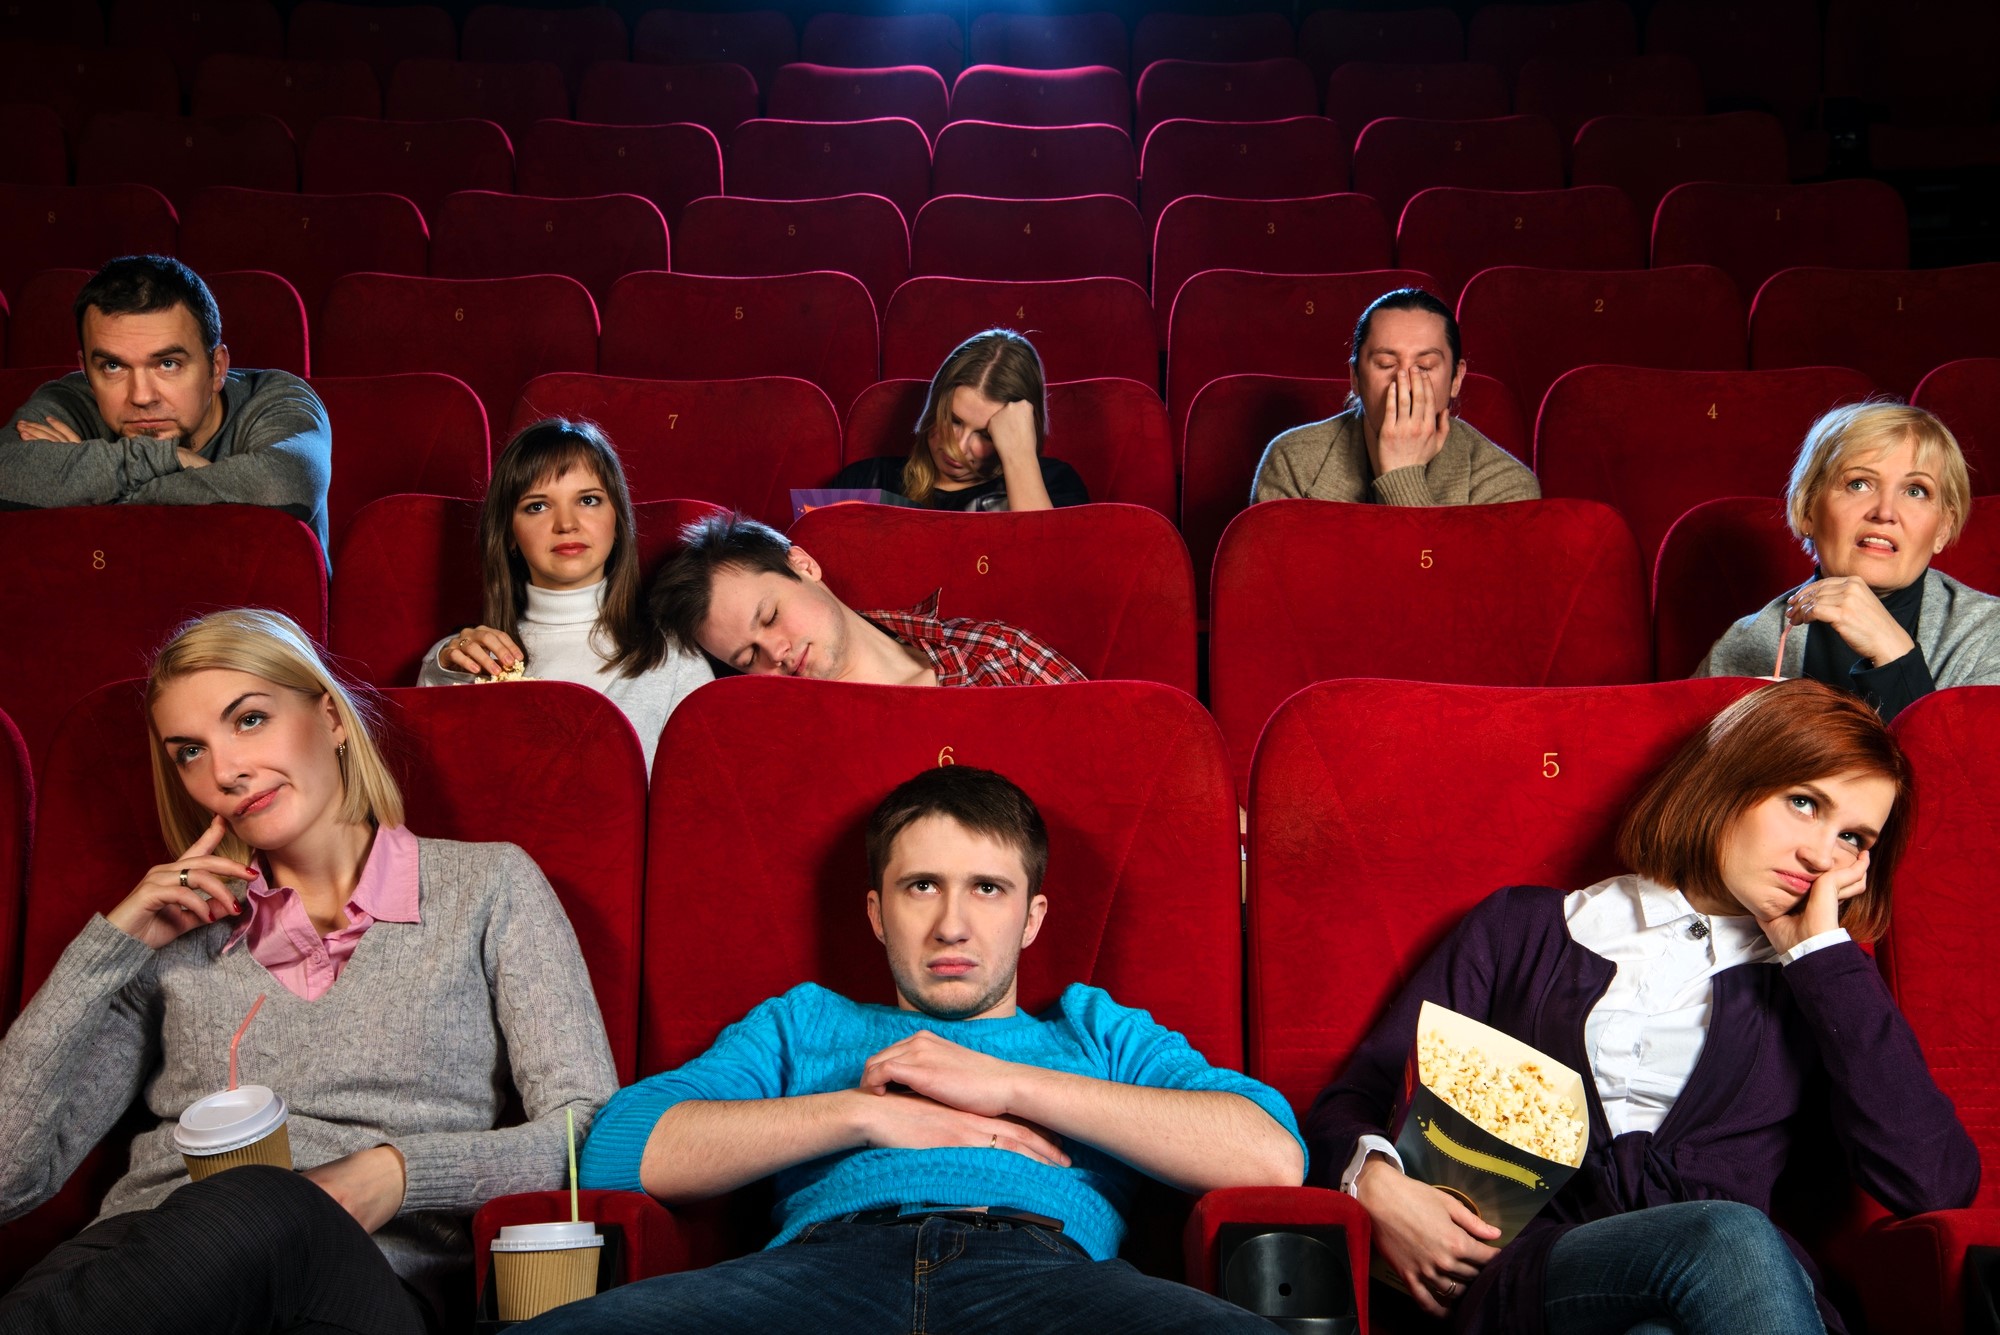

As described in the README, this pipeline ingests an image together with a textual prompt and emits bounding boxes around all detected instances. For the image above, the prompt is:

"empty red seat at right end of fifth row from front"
[1652,178,1910,302]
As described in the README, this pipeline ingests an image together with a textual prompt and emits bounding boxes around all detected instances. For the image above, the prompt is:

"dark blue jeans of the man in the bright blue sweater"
[518,1215,1274,1335]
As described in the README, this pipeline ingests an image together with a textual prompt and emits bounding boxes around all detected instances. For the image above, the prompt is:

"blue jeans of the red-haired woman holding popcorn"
[1542,1201,1826,1335]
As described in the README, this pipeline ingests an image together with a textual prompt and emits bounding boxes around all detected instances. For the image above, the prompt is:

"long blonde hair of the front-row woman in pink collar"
[146,608,402,861]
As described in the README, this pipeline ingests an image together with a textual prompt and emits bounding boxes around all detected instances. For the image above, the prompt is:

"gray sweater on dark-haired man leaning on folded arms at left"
[0,372,334,556]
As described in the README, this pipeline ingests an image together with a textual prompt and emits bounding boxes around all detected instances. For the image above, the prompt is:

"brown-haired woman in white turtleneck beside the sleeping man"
[418,418,714,773]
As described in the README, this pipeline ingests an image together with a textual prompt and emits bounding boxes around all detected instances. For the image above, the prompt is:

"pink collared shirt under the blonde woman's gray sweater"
[222,825,422,1001]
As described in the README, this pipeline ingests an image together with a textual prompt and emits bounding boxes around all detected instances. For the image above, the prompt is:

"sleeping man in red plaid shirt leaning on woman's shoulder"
[652,514,1084,685]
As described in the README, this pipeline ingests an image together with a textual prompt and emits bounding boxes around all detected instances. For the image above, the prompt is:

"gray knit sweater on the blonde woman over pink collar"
[0,839,618,1295]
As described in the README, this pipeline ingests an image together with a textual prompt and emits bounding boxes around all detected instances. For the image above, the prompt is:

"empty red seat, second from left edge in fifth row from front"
[180,186,430,316]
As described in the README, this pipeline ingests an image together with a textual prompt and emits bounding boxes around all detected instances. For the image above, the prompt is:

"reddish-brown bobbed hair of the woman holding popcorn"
[1618,677,1916,941]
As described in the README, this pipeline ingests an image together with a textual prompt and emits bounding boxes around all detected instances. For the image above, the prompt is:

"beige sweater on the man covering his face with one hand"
[1250,408,1542,506]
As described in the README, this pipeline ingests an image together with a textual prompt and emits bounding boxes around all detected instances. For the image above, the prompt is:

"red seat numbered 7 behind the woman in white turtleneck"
[510,372,840,530]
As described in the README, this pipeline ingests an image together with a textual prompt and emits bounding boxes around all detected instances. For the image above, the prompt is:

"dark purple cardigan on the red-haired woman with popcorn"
[1304,885,1980,1335]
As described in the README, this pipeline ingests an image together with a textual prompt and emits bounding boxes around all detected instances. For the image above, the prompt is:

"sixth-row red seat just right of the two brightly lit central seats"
[1138,116,1348,222]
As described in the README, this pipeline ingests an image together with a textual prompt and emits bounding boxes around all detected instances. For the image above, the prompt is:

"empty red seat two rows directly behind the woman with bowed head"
[910,194,1148,286]
